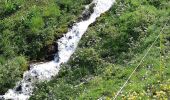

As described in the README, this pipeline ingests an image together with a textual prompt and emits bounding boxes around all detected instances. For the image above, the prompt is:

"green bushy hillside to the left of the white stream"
[0,0,91,94]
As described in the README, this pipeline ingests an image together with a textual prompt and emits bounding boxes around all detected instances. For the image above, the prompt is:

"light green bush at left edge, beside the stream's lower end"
[0,56,28,94]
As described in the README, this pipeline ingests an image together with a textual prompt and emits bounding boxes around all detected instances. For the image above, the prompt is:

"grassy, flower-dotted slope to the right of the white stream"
[31,0,170,100]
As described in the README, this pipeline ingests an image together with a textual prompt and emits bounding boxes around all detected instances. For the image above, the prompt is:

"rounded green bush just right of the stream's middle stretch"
[70,48,102,74]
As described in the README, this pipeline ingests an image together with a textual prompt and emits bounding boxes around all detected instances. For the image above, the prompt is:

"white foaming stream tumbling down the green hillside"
[2,0,115,100]
